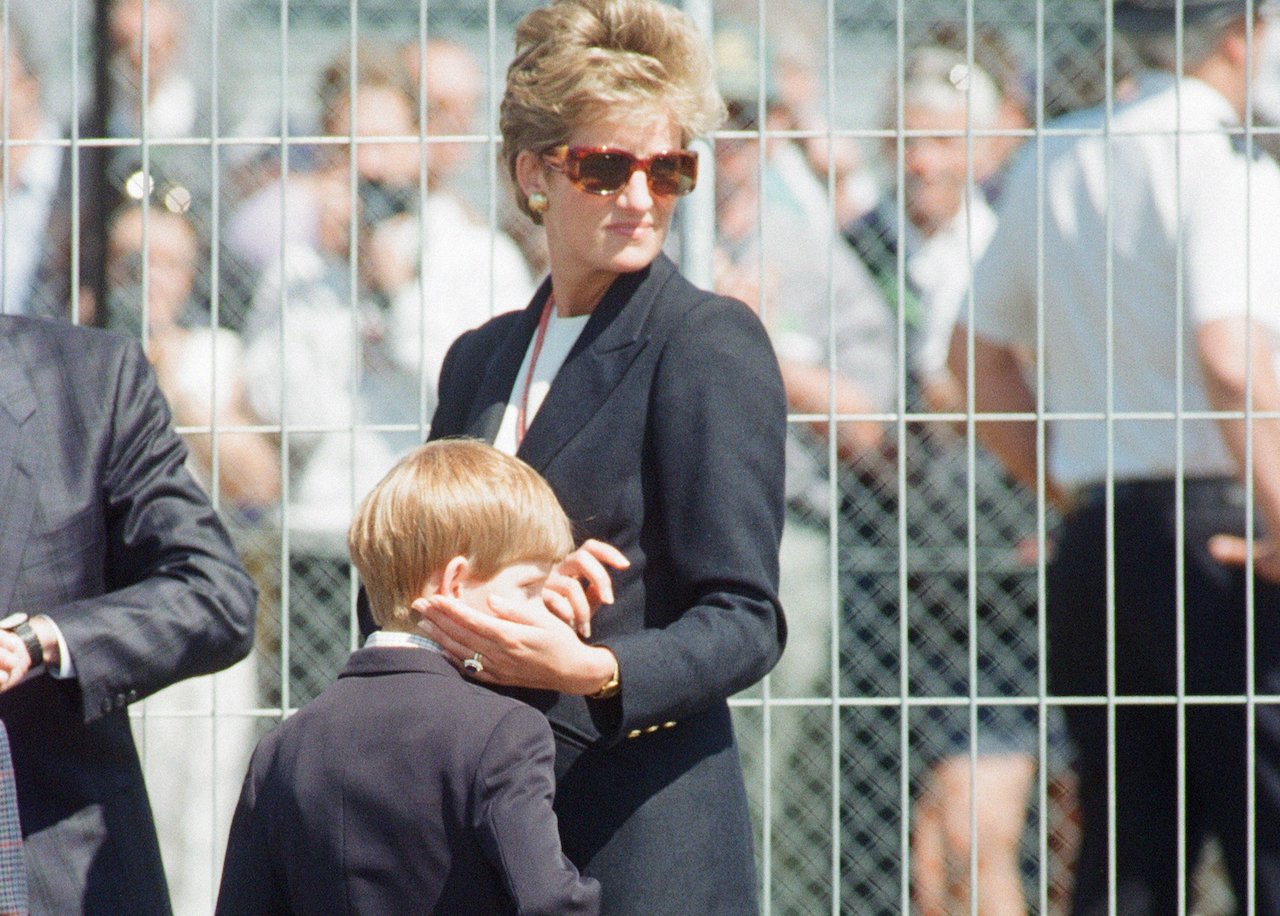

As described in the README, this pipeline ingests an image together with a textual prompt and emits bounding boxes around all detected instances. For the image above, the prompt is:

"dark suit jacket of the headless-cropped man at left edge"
[0,316,256,915]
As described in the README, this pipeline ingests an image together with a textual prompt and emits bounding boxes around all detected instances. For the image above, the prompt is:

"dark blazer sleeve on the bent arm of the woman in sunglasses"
[607,299,786,729]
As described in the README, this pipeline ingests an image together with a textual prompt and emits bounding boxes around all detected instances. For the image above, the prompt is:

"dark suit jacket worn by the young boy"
[218,647,600,916]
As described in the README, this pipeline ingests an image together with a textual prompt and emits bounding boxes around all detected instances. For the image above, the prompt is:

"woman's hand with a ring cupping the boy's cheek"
[413,595,617,696]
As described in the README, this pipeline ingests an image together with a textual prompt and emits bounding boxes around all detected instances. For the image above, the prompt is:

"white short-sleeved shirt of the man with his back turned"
[973,73,1280,486]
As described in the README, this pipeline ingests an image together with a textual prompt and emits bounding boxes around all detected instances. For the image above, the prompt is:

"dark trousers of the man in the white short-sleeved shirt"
[1047,481,1280,916]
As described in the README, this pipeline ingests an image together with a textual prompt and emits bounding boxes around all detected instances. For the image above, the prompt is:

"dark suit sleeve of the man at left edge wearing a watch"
[44,343,257,722]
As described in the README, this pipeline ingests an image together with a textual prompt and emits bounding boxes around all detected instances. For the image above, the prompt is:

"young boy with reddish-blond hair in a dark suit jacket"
[218,440,600,916]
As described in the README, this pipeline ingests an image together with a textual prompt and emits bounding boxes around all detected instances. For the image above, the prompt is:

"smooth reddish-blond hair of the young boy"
[347,439,573,629]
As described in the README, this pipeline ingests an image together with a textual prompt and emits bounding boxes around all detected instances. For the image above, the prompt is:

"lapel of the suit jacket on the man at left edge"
[0,330,36,616]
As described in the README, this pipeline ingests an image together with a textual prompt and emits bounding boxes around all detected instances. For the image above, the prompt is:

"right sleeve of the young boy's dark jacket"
[475,706,600,916]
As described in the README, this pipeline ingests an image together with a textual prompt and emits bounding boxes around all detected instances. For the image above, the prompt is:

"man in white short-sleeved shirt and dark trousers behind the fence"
[951,0,1280,913]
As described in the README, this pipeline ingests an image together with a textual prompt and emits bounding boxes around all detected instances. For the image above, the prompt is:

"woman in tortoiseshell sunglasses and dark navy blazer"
[426,0,786,916]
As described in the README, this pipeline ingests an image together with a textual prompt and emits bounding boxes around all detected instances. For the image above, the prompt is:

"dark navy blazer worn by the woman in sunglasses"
[431,256,786,916]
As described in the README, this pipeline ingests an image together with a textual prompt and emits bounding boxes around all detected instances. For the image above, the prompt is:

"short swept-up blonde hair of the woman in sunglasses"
[499,0,724,224]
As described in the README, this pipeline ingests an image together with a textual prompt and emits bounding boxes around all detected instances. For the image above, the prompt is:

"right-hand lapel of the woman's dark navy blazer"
[517,255,673,471]
